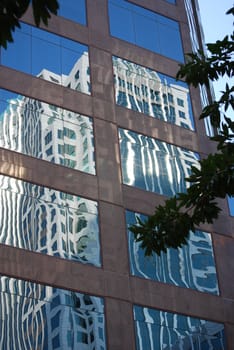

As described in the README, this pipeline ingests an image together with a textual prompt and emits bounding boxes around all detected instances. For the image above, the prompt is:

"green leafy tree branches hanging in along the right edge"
[129,7,234,255]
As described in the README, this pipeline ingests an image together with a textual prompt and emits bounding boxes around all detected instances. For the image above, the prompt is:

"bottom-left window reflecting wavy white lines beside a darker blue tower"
[0,276,106,350]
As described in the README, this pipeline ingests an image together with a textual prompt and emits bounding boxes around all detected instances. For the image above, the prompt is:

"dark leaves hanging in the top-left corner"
[0,0,59,49]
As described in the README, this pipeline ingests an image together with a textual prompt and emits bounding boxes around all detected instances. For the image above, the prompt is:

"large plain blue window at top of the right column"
[109,0,184,62]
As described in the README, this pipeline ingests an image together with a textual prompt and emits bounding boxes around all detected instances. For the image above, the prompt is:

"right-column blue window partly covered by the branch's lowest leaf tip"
[126,211,219,294]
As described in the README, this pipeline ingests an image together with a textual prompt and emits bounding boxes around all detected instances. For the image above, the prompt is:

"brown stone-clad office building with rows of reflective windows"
[0,0,234,350]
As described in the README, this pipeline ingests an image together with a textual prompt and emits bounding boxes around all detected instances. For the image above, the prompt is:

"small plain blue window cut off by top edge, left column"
[59,0,86,25]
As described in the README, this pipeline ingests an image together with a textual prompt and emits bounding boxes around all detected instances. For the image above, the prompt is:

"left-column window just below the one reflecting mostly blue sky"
[0,89,95,174]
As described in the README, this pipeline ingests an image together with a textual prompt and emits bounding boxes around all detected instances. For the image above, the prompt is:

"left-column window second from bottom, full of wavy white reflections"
[0,176,101,266]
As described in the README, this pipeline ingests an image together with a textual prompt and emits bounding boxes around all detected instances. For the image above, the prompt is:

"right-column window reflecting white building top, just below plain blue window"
[113,57,194,130]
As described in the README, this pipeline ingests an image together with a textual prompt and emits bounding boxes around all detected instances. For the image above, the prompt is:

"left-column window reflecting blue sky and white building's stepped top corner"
[0,23,90,94]
